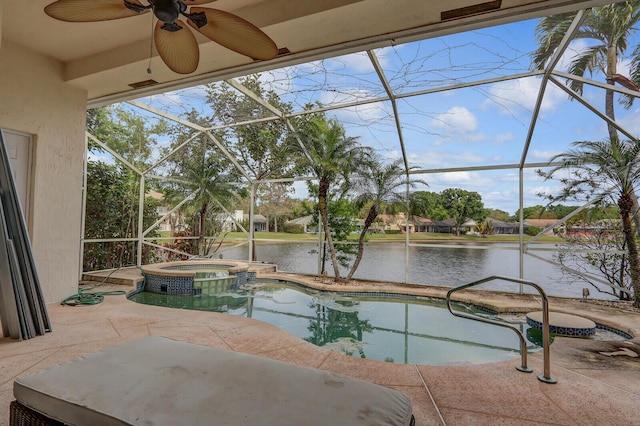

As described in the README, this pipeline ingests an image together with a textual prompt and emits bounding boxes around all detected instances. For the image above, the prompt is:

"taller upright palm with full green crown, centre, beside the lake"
[299,116,370,282]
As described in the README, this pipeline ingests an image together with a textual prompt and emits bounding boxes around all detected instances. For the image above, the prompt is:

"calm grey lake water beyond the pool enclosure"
[219,242,613,299]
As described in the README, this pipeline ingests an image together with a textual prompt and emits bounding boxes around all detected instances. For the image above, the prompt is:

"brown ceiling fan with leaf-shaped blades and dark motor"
[44,0,278,74]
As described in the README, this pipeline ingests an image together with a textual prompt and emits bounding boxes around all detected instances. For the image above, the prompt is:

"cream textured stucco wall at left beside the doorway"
[0,38,87,303]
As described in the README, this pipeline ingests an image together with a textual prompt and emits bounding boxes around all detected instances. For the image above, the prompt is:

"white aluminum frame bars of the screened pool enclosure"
[80,5,638,291]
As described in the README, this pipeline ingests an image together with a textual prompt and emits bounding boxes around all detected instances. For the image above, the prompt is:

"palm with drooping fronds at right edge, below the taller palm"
[540,138,640,308]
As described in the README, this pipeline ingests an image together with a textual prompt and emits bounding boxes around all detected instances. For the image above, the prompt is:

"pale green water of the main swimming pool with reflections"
[131,282,552,365]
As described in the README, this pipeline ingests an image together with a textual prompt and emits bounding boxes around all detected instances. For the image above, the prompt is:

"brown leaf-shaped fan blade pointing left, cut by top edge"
[44,0,151,22]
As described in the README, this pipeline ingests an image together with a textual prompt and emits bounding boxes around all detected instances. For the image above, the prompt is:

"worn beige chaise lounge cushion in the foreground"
[14,337,412,426]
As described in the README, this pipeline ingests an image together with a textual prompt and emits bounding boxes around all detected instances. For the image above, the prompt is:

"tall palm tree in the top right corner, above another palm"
[532,0,640,139]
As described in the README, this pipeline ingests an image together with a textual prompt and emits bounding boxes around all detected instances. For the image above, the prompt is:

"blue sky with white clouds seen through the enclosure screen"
[117,12,640,214]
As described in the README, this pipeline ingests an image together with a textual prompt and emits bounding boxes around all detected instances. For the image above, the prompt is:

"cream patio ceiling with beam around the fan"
[0,0,612,105]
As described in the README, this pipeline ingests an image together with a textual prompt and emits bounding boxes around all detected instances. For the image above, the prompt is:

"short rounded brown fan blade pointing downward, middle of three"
[153,20,200,74]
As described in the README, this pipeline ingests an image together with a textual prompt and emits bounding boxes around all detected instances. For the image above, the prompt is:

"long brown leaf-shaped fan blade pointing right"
[187,7,278,60]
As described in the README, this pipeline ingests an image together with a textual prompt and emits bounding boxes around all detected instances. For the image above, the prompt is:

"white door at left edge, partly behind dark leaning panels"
[2,129,31,223]
